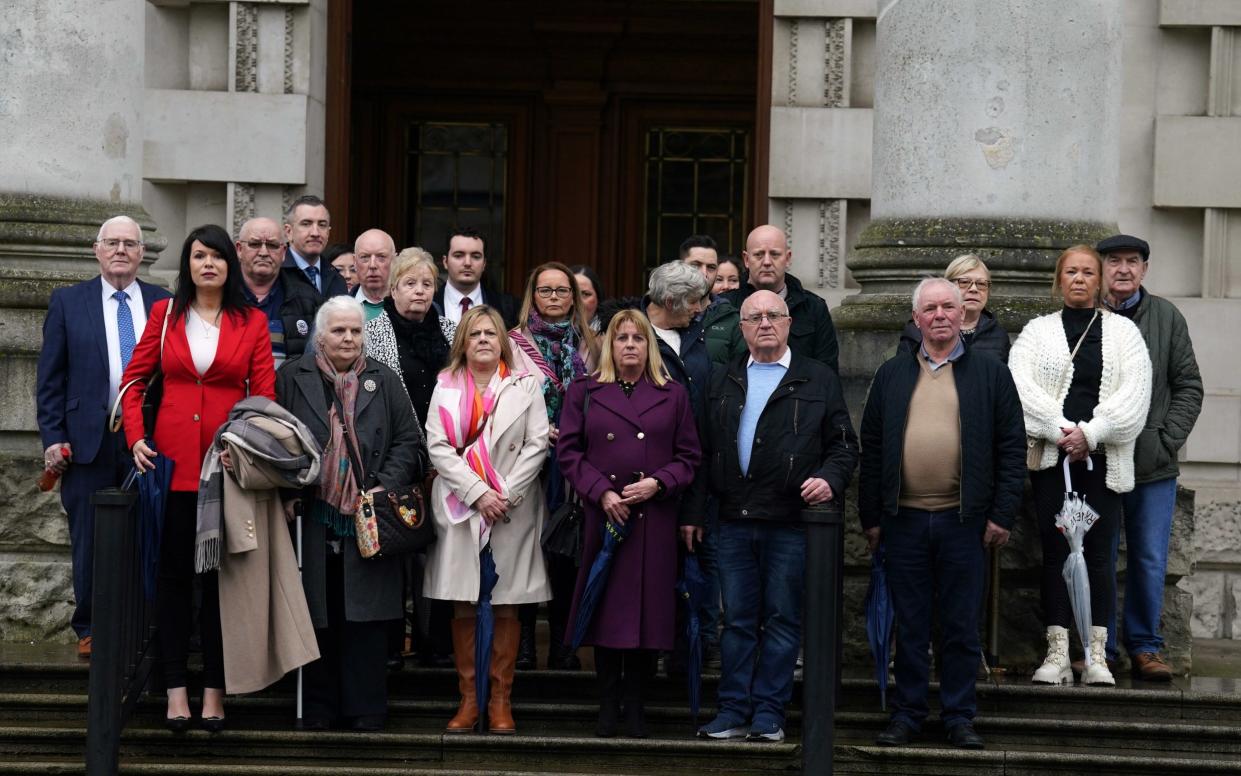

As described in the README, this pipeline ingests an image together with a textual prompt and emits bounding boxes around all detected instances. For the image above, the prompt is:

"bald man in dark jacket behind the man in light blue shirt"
[724,226,840,374]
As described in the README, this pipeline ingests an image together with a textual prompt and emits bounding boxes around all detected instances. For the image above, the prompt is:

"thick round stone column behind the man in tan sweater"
[834,0,1122,402]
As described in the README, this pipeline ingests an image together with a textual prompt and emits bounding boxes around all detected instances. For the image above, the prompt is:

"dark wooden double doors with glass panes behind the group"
[328,0,766,296]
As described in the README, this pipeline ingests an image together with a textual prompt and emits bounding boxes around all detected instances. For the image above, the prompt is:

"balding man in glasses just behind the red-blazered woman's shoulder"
[236,219,323,369]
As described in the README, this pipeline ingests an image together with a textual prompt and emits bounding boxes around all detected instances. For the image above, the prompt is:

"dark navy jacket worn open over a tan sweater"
[858,350,1025,528]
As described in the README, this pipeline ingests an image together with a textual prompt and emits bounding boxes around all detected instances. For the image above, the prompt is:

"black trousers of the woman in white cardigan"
[1030,454,1121,628]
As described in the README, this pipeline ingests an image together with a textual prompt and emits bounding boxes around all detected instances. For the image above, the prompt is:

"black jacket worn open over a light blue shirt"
[702,350,858,523]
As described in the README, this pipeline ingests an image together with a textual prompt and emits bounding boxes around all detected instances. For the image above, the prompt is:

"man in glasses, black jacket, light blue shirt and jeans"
[699,291,858,741]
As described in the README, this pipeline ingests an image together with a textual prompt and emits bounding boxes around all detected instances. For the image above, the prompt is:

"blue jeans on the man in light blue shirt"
[719,520,805,728]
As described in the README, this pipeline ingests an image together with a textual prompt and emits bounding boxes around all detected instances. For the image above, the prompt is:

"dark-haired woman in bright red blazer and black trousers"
[122,225,276,731]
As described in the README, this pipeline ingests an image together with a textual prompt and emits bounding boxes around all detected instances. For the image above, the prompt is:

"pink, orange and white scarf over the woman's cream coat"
[439,361,509,548]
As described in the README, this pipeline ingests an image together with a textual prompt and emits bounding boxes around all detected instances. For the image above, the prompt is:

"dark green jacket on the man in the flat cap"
[1122,288,1203,484]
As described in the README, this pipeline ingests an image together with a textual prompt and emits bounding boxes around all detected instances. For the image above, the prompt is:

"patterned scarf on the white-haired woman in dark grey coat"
[311,350,366,536]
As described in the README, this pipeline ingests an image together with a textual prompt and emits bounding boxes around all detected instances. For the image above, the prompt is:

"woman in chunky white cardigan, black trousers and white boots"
[1009,246,1150,685]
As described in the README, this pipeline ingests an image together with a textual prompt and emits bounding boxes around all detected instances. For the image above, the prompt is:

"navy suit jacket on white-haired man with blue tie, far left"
[35,277,171,464]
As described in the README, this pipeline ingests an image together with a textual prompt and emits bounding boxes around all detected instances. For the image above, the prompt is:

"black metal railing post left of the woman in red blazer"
[86,488,138,776]
